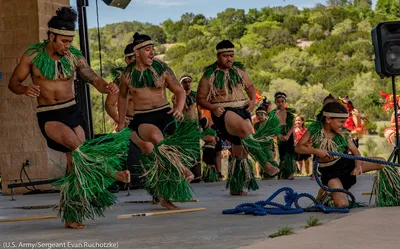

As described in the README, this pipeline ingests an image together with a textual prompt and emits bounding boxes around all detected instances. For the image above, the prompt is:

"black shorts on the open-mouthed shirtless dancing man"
[129,105,176,137]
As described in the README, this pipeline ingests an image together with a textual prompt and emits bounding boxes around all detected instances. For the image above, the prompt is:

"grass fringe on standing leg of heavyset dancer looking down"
[226,157,258,192]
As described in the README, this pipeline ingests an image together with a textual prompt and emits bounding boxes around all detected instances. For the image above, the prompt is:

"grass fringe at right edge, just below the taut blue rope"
[372,166,400,207]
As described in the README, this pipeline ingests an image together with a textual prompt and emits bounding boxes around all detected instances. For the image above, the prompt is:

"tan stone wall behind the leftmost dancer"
[0,0,69,194]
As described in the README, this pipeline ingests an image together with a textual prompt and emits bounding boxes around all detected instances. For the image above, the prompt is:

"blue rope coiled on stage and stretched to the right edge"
[222,152,390,216]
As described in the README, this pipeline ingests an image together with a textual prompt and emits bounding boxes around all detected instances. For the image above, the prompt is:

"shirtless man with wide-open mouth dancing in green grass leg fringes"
[118,33,200,209]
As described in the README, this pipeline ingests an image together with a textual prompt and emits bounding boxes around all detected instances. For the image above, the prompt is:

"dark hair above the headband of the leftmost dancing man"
[47,7,77,35]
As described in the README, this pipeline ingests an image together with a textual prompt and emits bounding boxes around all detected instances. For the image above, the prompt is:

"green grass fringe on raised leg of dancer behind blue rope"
[242,114,281,168]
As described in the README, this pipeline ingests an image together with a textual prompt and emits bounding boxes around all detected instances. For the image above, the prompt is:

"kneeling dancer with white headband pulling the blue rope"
[296,102,392,207]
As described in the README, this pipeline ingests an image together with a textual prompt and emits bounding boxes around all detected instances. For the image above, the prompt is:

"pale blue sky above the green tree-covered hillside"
[70,0,377,28]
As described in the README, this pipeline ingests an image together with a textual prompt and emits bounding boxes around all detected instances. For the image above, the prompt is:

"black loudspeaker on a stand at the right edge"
[371,21,400,79]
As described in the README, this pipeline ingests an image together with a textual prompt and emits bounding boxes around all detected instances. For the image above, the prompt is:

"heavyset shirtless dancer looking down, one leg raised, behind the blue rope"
[197,40,279,195]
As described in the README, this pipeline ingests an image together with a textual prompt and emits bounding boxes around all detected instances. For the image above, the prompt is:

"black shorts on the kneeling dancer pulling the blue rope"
[318,158,357,190]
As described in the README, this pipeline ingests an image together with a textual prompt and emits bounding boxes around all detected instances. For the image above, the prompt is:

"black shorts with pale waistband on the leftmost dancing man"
[36,99,85,152]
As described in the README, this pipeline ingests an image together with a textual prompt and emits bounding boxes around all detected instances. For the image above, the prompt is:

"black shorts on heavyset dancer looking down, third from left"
[211,106,251,145]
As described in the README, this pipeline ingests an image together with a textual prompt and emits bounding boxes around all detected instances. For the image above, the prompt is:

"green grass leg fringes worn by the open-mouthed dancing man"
[141,121,200,201]
